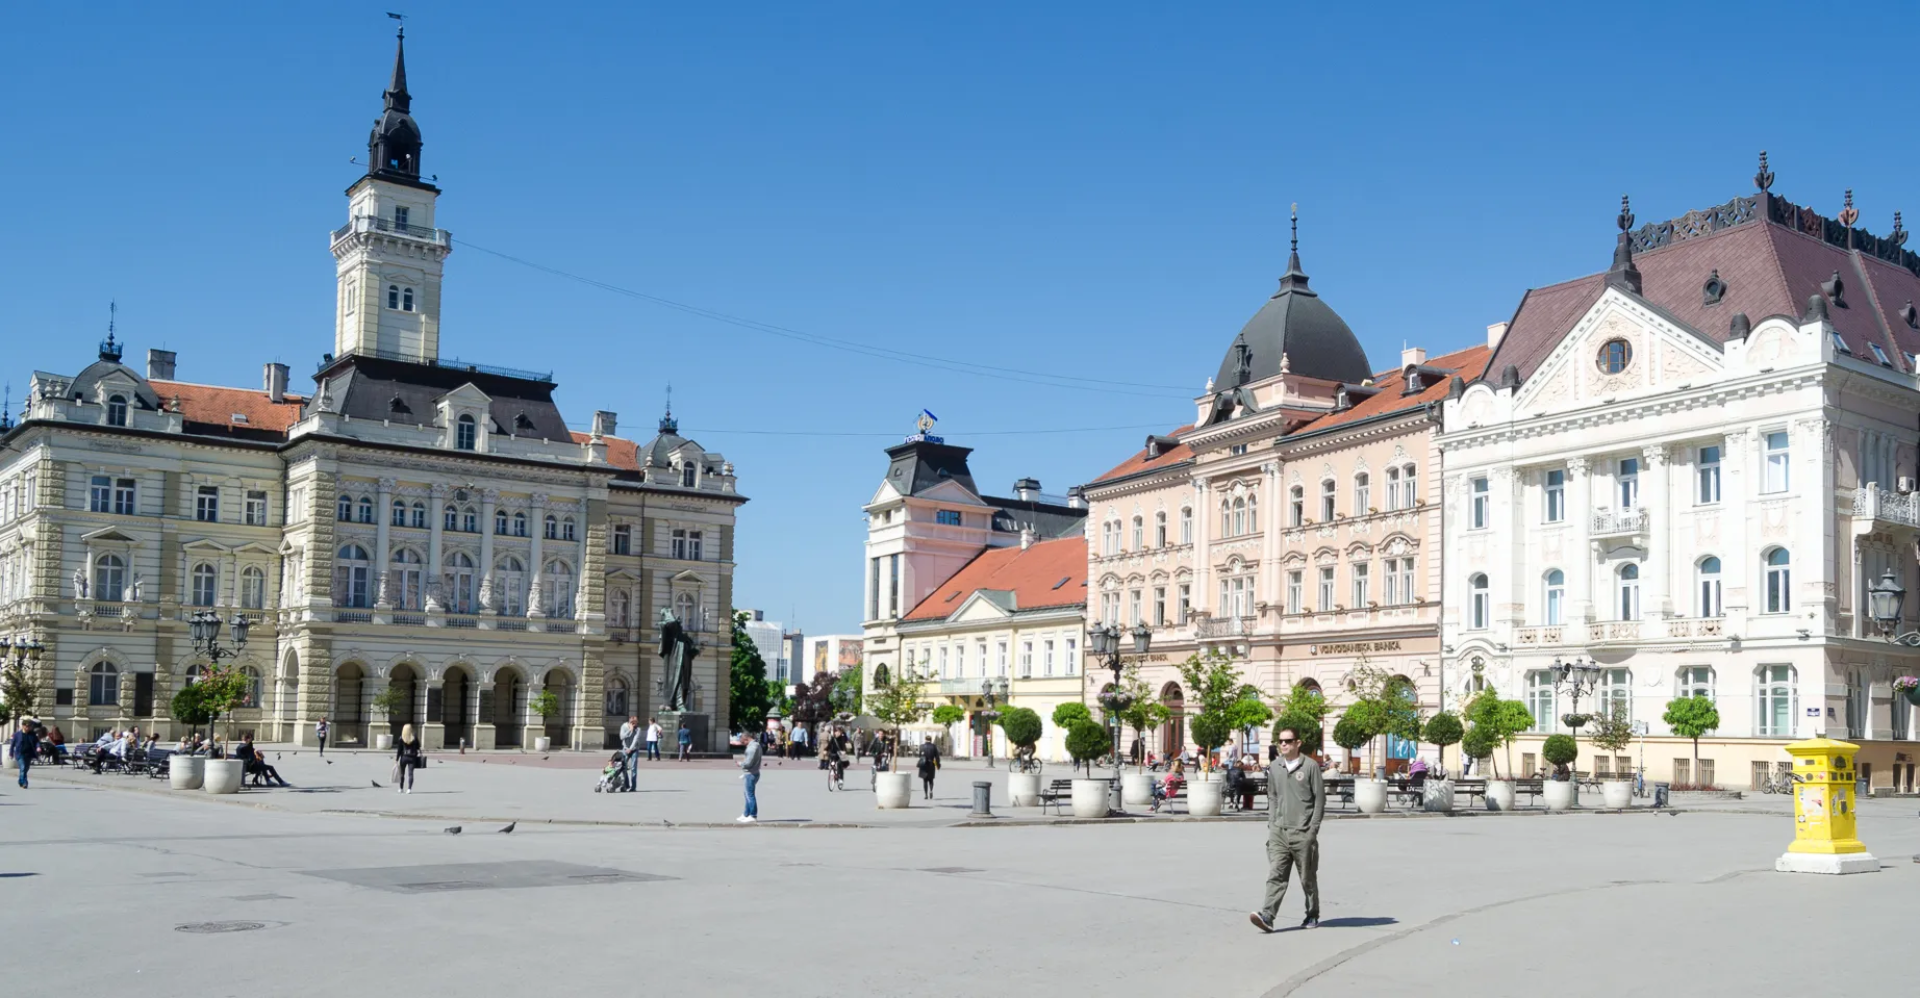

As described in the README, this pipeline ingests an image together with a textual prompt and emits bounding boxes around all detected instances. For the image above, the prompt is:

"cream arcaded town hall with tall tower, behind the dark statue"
[0,29,745,749]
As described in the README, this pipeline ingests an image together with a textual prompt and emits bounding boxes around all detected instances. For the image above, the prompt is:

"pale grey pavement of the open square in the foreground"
[0,756,1920,998]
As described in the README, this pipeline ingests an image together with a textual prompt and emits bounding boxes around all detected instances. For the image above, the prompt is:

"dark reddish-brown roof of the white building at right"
[1486,208,1920,380]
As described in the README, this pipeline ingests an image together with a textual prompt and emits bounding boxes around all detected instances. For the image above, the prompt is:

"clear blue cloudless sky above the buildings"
[0,0,1920,633]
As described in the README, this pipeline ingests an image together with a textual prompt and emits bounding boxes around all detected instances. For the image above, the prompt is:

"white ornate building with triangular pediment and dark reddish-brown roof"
[1438,173,1920,789]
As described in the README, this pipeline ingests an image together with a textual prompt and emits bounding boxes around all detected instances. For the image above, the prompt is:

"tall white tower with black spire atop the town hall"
[332,29,453,363]
